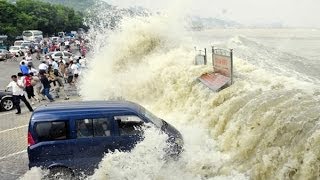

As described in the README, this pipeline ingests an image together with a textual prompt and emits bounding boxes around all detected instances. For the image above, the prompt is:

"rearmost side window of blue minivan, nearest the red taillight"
[35,121,68,142]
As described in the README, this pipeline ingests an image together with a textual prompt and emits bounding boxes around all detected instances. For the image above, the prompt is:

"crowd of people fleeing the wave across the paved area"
[6,38,86,114]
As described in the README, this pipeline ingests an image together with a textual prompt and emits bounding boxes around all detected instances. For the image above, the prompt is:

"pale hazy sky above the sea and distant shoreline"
[104,0,320,28]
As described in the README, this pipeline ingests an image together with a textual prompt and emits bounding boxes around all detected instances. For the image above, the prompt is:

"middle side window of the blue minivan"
[76,118,111,138]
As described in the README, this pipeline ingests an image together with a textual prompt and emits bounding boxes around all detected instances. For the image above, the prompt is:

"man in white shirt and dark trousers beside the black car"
[6,75,33,114]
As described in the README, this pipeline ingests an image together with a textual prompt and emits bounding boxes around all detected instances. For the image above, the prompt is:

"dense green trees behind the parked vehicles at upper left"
[0,0,86,37]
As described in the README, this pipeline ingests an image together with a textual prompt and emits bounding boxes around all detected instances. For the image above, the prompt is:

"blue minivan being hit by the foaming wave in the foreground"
[28,101,183,177]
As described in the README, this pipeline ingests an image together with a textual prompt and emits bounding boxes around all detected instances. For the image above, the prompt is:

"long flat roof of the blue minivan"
[33,101,141,115]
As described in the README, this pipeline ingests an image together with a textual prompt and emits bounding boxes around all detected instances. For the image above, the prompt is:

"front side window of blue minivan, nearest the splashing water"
[114,115,144,136]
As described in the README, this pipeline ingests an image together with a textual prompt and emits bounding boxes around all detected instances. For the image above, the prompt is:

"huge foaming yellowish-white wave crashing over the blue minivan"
[21,7,320,179]
